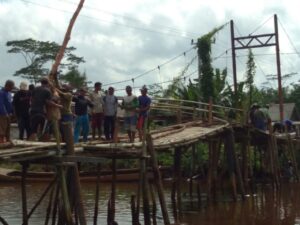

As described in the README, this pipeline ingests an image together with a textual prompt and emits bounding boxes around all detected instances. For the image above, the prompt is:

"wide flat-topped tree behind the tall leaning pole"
[6,38,85,83]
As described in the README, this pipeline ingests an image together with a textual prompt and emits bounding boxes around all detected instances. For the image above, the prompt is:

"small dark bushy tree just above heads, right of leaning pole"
[59,68,87,89]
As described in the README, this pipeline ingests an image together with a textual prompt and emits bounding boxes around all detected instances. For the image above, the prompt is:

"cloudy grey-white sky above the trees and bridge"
[0,0,300,92]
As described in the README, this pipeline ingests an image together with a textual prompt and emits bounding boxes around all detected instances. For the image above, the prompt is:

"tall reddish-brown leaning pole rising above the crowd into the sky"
[49,0,85,86]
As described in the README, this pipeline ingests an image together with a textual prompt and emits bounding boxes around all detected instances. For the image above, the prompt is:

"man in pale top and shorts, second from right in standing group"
[122,86,138,143]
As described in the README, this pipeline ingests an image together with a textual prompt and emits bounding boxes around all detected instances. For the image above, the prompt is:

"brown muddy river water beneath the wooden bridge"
[0,183,300,225]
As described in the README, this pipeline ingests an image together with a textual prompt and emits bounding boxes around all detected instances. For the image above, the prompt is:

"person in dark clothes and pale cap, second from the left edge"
[13,81,30,140]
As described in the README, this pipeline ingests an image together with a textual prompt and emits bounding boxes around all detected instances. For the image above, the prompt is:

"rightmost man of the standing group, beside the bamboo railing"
[137,85,151,141]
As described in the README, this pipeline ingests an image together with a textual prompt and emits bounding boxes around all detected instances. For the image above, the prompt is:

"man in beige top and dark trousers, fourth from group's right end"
[90,82,103,140]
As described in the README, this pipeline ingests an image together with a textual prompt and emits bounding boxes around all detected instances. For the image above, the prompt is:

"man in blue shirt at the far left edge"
[0,80,15,143]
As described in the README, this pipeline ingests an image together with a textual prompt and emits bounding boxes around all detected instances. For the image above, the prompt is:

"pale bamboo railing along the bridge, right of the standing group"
[151,98,245,123]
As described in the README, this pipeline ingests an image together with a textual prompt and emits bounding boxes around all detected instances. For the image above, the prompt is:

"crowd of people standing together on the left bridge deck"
[0,78,151,144]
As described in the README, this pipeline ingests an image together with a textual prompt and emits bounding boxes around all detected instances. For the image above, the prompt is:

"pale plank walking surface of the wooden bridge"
[0,121,228,161]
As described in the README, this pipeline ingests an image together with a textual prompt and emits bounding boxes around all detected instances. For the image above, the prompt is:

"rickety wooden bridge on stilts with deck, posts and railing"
[0,99,298,225]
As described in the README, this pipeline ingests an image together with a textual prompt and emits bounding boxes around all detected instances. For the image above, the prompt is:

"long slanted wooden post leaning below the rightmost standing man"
[146,134,170,225]
